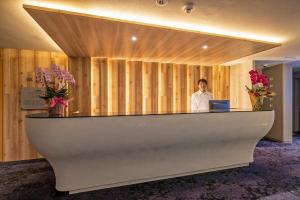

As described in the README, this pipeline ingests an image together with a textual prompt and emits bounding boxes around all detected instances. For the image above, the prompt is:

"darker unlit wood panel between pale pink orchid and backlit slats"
[68,57,91,115]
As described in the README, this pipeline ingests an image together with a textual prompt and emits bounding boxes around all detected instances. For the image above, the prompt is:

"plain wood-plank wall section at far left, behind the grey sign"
[0,49,68,161]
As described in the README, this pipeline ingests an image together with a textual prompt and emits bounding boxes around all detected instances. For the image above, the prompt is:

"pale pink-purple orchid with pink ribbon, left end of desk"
[36,65,75,108]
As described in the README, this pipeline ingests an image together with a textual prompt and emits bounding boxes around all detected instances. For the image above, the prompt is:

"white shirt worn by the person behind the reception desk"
[191,90,213,112]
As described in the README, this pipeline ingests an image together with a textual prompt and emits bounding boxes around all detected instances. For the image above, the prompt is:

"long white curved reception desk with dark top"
[26,110,274,193]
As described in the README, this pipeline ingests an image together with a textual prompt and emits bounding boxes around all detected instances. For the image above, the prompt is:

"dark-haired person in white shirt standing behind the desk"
[191,79,213,112]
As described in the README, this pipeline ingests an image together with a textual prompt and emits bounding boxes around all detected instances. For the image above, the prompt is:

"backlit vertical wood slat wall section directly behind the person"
[92,58,230,114]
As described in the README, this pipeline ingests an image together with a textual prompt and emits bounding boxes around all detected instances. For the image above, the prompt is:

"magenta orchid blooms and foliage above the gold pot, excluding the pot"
[246,70,275,97]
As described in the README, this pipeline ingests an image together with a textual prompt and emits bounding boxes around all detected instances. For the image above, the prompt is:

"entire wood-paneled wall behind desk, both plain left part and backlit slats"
[0,49,229,161]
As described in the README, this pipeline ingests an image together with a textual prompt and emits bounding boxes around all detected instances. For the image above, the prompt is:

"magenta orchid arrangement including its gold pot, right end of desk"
[246,70,275,111]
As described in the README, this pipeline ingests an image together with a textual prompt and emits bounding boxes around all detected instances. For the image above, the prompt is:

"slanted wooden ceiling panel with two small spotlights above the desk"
[24,5,280,65]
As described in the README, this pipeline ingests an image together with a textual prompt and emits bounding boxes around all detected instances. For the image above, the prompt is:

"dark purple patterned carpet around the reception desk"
[0,135,300,200]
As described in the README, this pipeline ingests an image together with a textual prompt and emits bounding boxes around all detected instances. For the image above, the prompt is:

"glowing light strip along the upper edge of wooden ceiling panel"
[26,0,284,44]
